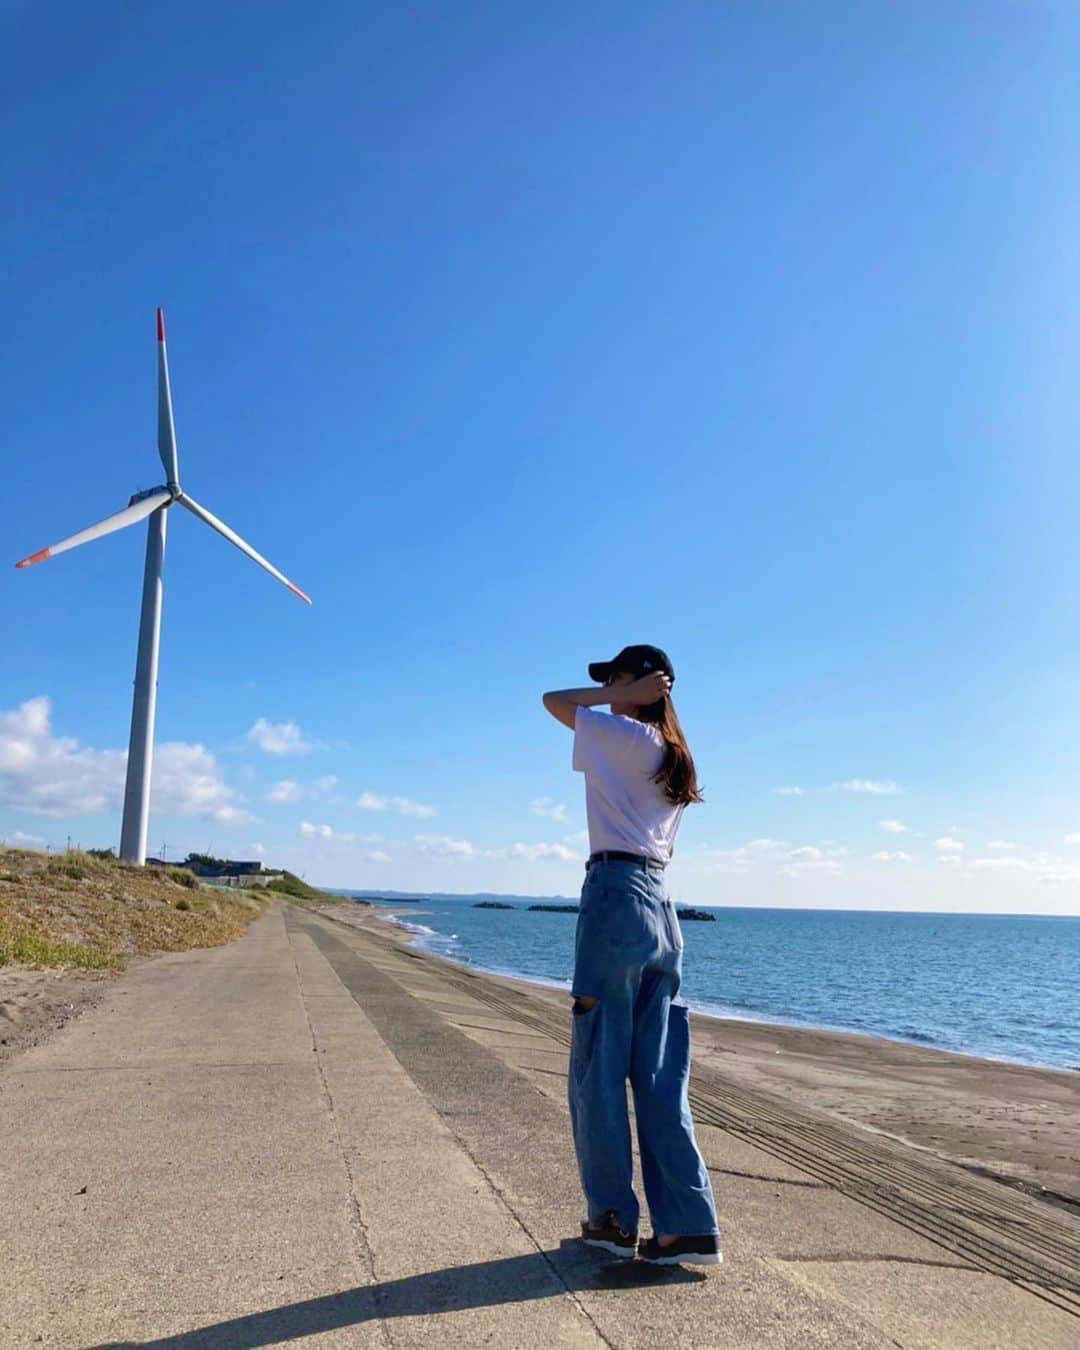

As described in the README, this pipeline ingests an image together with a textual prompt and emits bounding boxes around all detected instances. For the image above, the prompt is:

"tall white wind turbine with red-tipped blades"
[15,309,311,864]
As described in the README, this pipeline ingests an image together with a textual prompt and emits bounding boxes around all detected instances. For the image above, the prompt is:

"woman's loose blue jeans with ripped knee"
[568,861,720,1237]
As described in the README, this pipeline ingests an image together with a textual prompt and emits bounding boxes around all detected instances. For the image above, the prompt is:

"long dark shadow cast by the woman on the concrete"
[86,1239,706,1350]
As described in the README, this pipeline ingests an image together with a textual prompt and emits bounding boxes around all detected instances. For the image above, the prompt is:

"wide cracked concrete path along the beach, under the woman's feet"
[0,905,1080,1350]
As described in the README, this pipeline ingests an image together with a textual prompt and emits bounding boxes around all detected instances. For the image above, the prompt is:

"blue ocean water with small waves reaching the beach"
[351,892,1080,1068]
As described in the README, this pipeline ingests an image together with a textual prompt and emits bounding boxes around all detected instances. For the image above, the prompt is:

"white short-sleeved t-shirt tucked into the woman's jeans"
[574,707,683,863]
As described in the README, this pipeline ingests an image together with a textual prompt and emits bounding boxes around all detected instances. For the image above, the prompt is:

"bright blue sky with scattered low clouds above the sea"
[0,3,1080,913]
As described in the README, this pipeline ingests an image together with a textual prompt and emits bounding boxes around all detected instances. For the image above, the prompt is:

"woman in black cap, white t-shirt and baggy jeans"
[544,647,721,1265]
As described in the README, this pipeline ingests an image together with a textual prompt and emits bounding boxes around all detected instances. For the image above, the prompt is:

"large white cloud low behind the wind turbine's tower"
[0,697,254,825]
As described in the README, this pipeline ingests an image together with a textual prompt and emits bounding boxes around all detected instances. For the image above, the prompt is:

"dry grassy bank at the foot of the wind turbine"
[0,849,273,969]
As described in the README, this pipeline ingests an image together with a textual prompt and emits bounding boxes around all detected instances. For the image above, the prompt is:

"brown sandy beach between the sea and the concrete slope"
[327,906,1080,1214]
